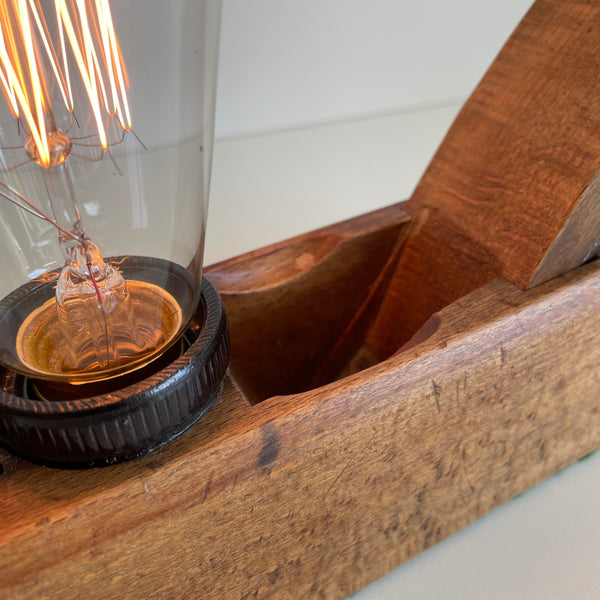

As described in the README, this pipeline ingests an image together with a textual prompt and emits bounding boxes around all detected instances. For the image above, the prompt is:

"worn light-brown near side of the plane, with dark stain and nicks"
[0,263,600,600]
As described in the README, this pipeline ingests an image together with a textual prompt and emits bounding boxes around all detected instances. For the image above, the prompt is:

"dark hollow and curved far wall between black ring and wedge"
[206,204,410,403]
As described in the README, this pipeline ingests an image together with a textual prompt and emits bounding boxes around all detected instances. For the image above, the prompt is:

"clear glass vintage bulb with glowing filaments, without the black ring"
[0,0,220,385]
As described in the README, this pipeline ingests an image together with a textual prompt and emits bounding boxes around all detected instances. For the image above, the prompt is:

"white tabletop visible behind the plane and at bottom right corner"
[205,104,600,600]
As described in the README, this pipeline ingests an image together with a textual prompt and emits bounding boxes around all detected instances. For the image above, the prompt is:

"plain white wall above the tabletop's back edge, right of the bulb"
[217,0,532,138]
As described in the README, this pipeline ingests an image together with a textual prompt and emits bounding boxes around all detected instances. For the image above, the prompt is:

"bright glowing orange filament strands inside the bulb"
[0,0,131,167]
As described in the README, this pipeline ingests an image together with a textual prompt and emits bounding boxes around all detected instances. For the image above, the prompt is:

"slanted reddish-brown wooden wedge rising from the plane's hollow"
[368,0,600,359]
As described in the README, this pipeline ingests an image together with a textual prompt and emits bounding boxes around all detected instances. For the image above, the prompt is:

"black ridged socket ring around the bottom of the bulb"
[0,278,230,468]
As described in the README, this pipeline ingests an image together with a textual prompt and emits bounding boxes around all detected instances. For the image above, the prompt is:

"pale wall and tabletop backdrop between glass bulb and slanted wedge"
[205,0,531,264]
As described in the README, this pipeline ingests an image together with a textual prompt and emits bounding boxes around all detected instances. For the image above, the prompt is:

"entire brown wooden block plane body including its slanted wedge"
[0,0,600,600]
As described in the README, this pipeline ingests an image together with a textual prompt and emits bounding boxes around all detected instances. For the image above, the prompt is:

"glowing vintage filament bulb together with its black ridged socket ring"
[0,0,229,467]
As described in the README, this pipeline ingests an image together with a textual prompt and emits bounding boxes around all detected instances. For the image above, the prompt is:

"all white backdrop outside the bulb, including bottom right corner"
[205,0,600,600]
